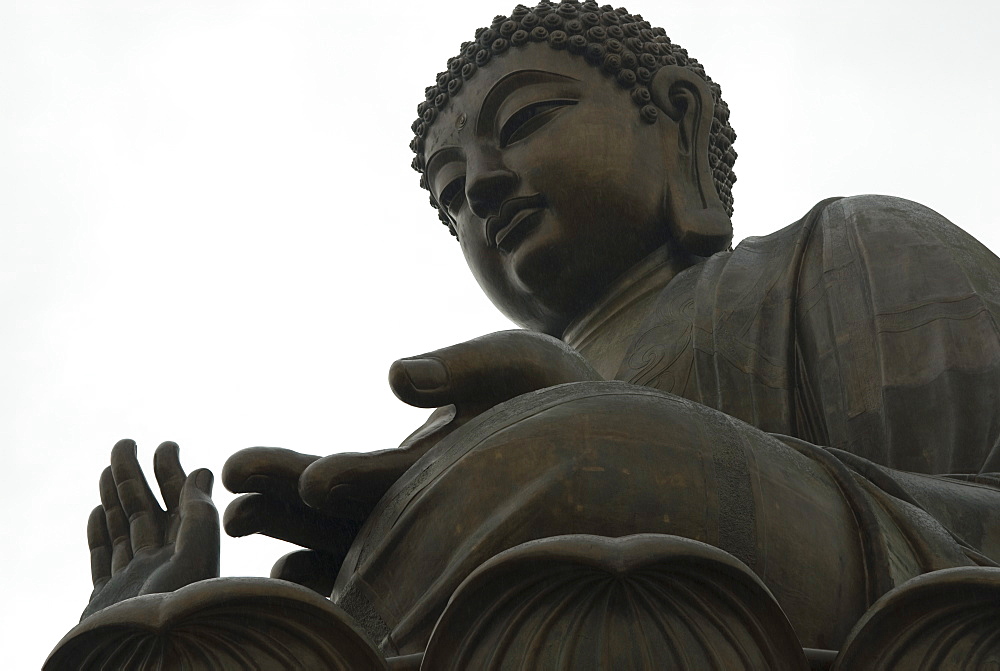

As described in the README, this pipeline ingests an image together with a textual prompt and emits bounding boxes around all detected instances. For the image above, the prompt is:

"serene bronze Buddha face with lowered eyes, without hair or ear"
[425,45,676,336]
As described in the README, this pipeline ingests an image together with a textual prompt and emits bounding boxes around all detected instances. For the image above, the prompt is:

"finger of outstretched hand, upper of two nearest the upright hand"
[222,447,319,503]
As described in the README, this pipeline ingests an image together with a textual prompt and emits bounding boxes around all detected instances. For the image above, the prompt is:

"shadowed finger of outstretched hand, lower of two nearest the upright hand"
[222,494,360,554]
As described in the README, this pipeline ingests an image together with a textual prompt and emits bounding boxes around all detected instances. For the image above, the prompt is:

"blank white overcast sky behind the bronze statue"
[0,0,1000,668]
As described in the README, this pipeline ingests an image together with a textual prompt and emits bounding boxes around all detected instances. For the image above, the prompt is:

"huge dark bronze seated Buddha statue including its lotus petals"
[49,0,1000,669]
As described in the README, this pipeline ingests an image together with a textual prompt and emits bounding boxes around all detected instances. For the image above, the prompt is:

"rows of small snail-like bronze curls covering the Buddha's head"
[410,0,736,234]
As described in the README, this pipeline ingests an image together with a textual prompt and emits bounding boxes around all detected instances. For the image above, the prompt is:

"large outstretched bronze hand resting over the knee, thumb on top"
[222,331,601,594]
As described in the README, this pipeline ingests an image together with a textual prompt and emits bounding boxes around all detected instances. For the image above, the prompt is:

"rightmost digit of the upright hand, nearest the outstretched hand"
[172,468,219,584]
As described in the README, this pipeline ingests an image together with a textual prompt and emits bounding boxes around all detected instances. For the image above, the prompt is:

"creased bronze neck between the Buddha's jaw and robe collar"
[562,244,699,379]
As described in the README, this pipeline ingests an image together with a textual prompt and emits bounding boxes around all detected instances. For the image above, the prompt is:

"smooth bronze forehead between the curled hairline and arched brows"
[424,44,630,158]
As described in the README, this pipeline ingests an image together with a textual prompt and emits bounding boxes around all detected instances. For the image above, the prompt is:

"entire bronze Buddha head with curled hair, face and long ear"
[411,0,736,335]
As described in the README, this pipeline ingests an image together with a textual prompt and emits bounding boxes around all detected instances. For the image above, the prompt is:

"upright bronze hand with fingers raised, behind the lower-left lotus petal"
[81,440,219,619]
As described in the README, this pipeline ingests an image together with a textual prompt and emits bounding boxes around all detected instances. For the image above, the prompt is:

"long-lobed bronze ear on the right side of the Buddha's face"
[649,65,733,256]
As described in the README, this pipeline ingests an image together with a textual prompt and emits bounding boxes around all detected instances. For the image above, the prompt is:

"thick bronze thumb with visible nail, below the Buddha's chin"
[389,331,602,408]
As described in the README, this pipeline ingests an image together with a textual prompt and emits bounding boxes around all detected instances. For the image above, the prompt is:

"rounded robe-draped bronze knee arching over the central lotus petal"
[333,382,968,653]
